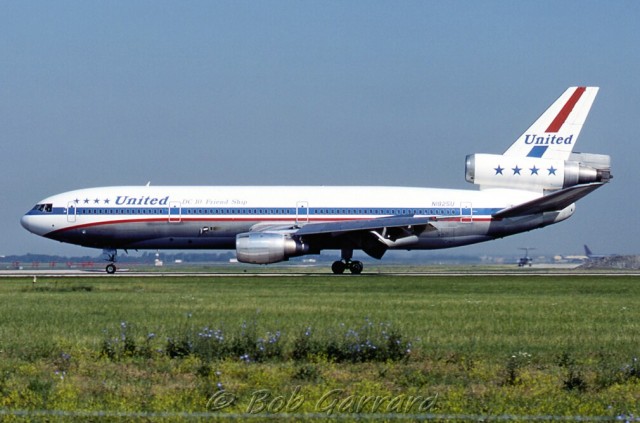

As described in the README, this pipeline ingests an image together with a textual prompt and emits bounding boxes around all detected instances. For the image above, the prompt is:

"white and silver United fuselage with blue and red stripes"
[22,186,574,249]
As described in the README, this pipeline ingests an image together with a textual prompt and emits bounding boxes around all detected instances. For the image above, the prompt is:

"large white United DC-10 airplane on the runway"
[21,86,612,274]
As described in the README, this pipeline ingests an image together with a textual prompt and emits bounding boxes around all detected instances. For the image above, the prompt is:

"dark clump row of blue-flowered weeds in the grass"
[100,319,411,363]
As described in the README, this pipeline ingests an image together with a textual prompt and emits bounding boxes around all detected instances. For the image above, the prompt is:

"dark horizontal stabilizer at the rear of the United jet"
[492,182,605,218]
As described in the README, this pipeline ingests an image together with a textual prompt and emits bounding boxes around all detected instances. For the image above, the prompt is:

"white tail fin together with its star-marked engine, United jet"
[466,87,611,195]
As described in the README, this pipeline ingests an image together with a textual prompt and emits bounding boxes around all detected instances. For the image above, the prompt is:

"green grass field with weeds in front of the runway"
[0,275,640,421]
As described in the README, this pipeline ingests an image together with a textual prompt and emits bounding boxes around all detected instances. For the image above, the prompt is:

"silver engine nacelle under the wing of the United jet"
[236,232,308,264]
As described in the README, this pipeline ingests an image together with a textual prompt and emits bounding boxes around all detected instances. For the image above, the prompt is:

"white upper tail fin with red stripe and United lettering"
[504,87,599,160]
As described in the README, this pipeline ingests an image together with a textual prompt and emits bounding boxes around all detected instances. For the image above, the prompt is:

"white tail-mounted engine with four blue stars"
[465,153,612,191]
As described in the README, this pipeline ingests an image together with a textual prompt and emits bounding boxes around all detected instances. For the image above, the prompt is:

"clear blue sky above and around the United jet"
[0,0,640,255]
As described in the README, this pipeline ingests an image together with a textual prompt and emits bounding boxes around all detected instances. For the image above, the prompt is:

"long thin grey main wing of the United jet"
[295,216,435,236]
